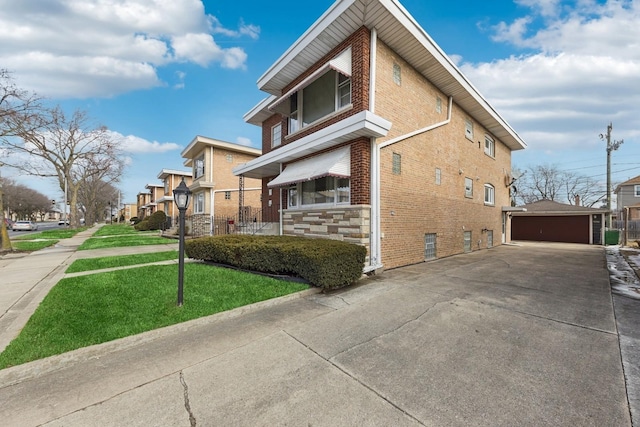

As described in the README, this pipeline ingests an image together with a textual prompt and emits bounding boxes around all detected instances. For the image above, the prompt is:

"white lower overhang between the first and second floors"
[233,111,391,178]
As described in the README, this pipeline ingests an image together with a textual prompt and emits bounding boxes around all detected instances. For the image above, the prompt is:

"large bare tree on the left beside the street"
[2,107,124,226]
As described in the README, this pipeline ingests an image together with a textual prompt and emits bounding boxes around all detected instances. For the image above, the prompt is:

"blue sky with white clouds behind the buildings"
[0,0,640,202]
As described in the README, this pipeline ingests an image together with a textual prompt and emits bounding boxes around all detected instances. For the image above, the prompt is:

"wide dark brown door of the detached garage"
[511,215,589,243]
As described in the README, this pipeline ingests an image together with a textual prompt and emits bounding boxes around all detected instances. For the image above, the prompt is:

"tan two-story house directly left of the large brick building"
[181,136,261,235]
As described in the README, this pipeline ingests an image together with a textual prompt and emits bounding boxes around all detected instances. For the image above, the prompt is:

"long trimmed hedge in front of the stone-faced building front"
[185,235,367,289]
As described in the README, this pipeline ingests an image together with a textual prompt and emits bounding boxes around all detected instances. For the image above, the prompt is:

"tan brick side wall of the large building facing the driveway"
[376,42,511,268]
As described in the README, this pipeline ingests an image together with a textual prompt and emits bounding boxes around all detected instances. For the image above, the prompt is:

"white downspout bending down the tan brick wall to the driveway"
[365,95,453,273]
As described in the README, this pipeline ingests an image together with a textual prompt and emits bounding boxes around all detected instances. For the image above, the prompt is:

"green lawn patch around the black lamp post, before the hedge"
[0,264,308,369]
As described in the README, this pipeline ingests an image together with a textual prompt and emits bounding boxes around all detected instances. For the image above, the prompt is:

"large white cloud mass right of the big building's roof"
[459,0,640,160]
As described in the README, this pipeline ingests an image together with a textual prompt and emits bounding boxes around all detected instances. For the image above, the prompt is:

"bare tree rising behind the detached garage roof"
[516,165,606,207]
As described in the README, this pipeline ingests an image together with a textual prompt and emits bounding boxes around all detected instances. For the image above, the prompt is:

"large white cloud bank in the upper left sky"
[0,0,260,98]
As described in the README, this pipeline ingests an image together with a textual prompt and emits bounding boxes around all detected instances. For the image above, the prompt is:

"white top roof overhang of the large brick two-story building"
[245,0,527,150]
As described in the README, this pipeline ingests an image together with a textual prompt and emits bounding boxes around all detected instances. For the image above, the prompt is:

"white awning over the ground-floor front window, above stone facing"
[267,147,351,187]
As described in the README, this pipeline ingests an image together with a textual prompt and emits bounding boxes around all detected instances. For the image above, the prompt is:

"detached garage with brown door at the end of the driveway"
[511,200,608,245]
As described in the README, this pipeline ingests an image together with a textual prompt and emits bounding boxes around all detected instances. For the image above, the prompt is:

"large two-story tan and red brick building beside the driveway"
[234,0,526,272]
